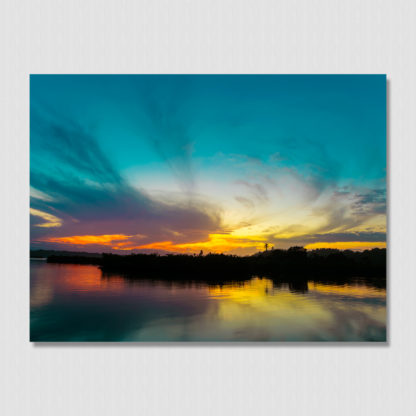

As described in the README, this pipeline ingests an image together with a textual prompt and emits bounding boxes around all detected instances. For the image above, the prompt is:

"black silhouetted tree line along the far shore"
[47,247,386,282]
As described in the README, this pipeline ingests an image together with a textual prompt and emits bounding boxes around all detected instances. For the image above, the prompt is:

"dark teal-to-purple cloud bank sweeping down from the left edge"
[31,108,220,250]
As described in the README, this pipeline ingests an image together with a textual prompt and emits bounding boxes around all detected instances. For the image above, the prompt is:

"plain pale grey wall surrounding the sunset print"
[0,0,416,416]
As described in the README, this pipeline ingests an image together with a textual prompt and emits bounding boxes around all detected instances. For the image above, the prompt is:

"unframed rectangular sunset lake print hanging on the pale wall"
[30,74,387,342]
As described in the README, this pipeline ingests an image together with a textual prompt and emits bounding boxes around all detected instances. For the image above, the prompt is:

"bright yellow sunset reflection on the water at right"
[205,278,386,340]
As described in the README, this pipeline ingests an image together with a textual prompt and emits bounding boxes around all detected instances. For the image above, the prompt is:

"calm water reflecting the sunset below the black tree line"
[30,260,386,341]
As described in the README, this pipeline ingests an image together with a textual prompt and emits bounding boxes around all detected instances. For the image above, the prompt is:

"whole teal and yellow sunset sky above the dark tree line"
[30,75,386,255]
